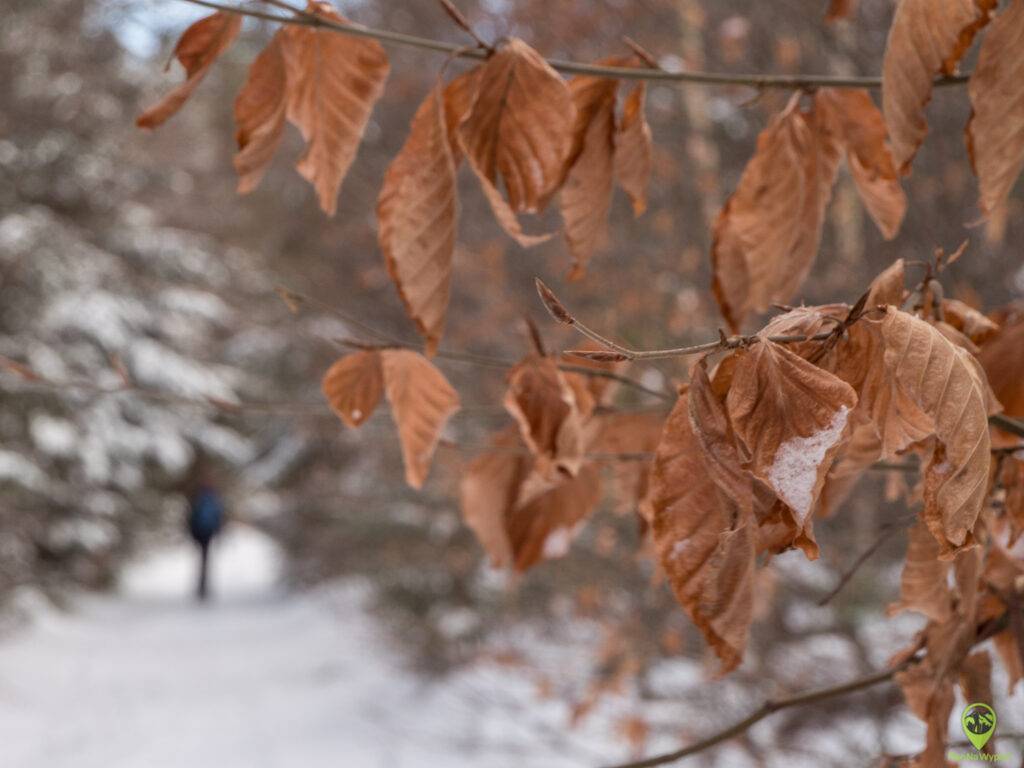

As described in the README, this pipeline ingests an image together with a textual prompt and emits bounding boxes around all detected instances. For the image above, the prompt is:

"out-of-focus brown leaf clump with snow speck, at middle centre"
[460,354,662,570]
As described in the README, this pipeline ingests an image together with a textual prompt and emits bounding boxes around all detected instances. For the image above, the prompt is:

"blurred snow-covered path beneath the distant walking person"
[0,529,610,768]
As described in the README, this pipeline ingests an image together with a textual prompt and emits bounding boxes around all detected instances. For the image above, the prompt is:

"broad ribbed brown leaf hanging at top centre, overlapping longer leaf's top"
[458,38,575,240]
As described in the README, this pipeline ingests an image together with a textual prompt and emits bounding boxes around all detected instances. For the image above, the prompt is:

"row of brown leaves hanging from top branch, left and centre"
[137,6,651,354]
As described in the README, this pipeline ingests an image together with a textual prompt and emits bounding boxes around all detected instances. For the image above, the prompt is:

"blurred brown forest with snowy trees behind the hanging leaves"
[0,0,1024,766]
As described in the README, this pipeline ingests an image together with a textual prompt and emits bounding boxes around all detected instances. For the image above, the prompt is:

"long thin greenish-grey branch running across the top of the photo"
[172,0,971,90]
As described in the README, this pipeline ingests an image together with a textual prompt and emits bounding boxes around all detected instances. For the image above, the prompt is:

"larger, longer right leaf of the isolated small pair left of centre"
[380,349,459,488]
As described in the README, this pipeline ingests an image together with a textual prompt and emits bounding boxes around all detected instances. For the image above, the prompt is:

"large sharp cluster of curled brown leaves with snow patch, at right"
[650,262,1019,670]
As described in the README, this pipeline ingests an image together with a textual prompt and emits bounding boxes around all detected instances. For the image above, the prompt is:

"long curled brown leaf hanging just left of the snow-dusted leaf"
[650,392,757,673]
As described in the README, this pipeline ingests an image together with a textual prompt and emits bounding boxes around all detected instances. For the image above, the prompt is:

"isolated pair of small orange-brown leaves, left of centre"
[323,349,459,488]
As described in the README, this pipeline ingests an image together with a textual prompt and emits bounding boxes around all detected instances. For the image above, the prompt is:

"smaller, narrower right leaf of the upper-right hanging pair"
[814,88,906,240]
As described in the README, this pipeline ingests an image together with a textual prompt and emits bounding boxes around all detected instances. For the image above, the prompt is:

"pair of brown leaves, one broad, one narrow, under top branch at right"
[712,88,906,331]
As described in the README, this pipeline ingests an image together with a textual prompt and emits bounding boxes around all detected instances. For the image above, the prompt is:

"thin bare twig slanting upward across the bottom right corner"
[607,613,1009,768]
